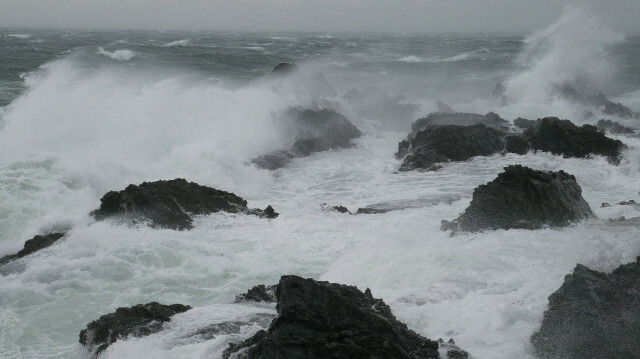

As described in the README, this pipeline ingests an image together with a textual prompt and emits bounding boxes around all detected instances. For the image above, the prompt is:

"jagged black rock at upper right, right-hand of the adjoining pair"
[525,117,626,163]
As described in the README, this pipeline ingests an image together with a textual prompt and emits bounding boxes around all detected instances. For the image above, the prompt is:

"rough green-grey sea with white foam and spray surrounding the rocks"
[0,10,640,359]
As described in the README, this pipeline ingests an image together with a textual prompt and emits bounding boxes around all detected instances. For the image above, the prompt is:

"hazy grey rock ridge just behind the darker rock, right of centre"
[409,112,509,137]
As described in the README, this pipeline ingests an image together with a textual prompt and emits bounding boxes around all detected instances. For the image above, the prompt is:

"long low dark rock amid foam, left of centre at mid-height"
[91,178,278,230]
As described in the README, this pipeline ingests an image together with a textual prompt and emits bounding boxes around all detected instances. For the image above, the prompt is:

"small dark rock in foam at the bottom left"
[79,302,191,354]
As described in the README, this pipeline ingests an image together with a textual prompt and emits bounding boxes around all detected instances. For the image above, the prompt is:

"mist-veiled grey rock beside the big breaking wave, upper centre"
[252,108,362,170]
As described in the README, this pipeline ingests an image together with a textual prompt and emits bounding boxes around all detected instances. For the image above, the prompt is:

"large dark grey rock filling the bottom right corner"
[531,257,640,359]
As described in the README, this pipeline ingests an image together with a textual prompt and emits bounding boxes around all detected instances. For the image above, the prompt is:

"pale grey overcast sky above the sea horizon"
[0,0,640,33]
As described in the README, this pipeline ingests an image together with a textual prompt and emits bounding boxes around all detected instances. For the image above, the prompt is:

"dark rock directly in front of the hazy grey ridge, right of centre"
[396,124,504,171]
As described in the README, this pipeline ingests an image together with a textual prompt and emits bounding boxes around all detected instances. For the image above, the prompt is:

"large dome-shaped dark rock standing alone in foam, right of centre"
[442,165,593,232]
